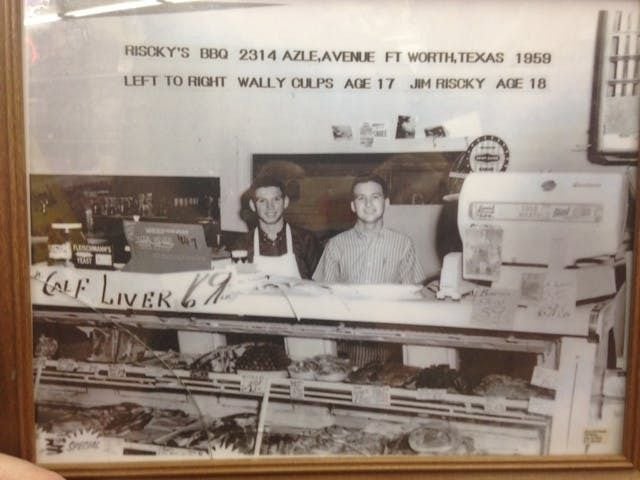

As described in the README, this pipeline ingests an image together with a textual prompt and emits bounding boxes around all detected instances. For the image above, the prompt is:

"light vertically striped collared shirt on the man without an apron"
[313,225,424,284]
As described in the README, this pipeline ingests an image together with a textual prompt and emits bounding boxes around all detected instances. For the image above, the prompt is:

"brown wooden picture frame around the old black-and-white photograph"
[0,2,640,479]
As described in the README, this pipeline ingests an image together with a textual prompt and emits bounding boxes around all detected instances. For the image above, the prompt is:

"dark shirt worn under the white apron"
[246,224,322,279]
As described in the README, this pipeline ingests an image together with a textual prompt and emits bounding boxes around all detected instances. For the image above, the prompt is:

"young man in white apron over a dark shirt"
[247,177,322,279]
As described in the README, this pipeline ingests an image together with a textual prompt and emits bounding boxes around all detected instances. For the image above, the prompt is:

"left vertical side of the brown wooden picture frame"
[0,1,34,458]
